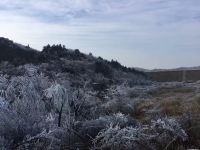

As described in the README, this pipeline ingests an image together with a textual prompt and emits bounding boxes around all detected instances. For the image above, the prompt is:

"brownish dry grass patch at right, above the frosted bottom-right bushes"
[130,86,200,122]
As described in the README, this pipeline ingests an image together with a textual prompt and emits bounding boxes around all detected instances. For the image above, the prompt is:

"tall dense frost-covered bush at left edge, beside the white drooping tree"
[0,74,49,146]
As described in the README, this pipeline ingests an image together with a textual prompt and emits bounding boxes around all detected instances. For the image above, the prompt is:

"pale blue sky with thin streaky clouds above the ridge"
[0,0,200,69]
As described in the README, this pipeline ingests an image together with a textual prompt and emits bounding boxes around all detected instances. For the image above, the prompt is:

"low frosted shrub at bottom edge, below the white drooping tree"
[17,127,86,150]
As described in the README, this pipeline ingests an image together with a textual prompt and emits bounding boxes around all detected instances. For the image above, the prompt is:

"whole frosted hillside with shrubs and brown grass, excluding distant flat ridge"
[0,38,200,150]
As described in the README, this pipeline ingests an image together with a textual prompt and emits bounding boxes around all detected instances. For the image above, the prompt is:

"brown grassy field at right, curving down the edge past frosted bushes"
[132,82,200,149]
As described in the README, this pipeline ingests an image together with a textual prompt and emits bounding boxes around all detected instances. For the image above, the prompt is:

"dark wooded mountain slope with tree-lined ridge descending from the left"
[0,38,146,84]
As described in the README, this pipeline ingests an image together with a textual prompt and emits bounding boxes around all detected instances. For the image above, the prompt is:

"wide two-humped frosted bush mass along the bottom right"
[92,118,187,150]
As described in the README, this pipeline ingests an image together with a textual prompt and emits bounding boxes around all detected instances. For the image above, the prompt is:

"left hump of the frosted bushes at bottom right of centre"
[92,125,152,150]
